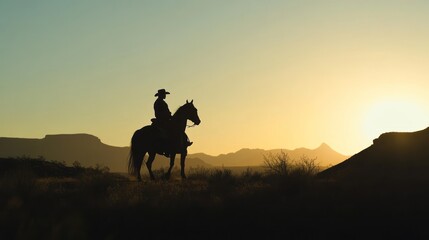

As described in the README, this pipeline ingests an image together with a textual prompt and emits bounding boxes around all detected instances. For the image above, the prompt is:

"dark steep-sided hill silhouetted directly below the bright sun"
[319,128,429,184]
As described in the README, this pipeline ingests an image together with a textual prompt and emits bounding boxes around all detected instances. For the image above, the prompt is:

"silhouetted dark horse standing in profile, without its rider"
[128,100,201,181]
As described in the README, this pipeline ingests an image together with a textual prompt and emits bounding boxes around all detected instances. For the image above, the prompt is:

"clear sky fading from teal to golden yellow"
[0,0,429,155]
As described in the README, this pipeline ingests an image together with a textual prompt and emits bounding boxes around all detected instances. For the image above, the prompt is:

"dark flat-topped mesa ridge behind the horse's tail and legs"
[0,134,210,172]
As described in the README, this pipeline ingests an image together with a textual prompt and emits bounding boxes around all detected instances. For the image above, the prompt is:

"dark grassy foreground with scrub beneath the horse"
[0,155,429,239]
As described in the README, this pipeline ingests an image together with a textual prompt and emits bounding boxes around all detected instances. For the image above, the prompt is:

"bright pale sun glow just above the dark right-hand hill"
[364,100,429,139]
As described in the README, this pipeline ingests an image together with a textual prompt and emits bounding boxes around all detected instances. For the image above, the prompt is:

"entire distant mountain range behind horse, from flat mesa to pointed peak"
[0,134,347,172]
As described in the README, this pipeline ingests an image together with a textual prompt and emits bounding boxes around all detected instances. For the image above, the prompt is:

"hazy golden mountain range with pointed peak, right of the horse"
[190,143,347,166]
